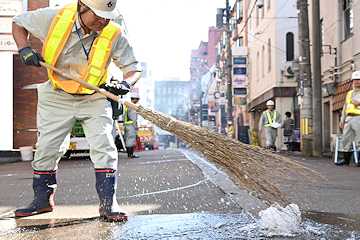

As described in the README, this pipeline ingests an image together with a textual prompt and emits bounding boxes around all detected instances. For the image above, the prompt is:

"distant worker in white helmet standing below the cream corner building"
[259,100,282,151]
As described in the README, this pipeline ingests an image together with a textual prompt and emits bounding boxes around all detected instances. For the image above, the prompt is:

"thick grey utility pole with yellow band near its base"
[297,0,313,156]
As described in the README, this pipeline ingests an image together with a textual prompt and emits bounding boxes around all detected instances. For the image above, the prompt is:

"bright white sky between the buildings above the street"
[50,0,229,81]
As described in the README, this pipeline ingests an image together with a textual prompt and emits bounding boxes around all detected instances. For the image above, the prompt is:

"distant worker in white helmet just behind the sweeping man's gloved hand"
[124,92,140,158]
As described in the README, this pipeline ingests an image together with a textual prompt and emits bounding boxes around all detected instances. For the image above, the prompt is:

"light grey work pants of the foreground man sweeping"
[32,81,118,171]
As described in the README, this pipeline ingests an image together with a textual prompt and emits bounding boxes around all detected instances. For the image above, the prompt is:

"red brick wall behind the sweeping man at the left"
[13,0,49,149]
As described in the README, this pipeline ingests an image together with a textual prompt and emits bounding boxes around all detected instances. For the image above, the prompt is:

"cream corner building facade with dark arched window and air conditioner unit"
[247,0,299,149]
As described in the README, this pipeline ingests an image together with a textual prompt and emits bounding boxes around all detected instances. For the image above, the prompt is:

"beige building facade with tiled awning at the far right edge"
[309,0,360,152]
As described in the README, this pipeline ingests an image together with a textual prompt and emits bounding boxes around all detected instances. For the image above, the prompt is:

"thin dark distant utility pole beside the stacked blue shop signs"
[225,0,233,123]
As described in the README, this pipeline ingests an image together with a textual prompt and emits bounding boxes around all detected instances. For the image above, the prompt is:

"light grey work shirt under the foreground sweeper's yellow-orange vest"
[13,8,142,80]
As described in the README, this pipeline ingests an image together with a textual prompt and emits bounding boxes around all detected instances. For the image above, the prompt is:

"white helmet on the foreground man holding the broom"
[81,0,120,19]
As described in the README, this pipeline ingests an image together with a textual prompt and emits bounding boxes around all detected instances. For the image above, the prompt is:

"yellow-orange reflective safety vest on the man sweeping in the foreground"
[42,3,121,94]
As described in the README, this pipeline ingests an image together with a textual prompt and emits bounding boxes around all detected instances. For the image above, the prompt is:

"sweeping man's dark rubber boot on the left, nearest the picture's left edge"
[15,171,57,217]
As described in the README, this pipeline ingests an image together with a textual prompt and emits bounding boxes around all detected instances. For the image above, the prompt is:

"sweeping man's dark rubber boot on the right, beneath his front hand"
[95,169,128,221]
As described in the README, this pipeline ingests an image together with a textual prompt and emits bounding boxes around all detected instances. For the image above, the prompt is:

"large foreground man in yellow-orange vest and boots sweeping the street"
[12,0,142,221]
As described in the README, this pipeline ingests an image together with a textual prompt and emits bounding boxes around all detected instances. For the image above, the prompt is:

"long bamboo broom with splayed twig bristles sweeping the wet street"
[40,62,325,205]
